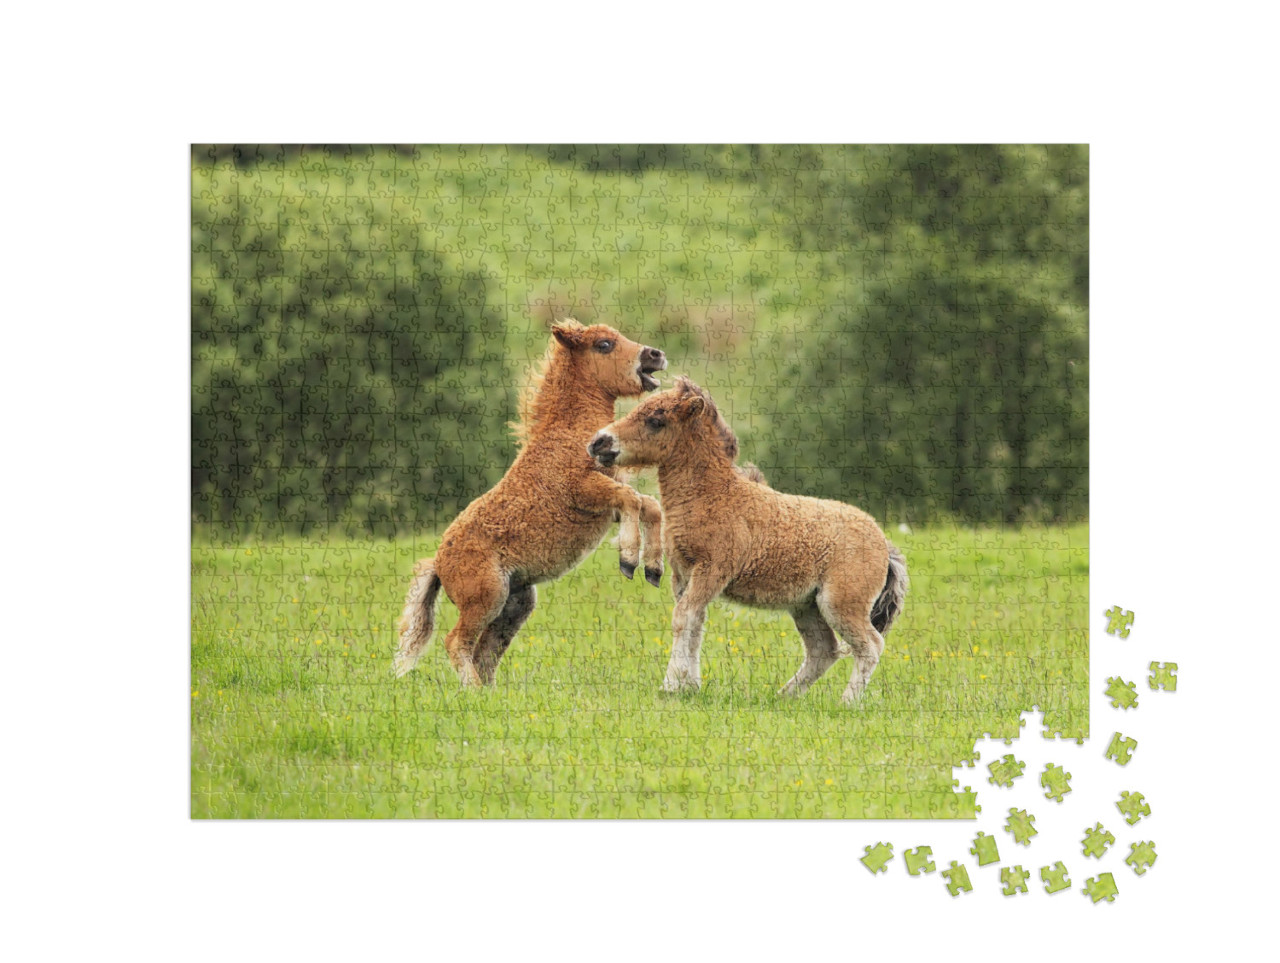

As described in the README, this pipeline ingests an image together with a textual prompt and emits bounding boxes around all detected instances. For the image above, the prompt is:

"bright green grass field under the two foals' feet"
[191,525,1088,818]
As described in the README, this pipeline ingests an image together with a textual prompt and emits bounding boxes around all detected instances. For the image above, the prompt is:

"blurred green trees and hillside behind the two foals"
[192,145,1088,538]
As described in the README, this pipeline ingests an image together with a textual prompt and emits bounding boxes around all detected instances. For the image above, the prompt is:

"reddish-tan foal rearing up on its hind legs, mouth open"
[394,319,667,685]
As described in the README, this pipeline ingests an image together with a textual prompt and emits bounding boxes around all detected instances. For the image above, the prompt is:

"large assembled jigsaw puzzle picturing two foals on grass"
[184,145,1090,819]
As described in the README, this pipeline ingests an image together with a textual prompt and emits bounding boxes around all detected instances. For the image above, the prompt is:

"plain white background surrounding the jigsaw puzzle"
[0,3,1277,959]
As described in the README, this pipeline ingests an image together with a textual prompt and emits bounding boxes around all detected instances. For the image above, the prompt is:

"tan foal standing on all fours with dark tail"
[588,378,908,702]
